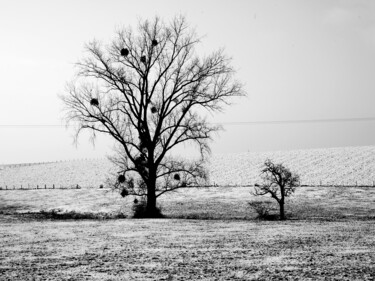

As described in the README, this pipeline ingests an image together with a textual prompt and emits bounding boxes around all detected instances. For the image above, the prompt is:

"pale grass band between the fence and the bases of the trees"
[0,187,375,220]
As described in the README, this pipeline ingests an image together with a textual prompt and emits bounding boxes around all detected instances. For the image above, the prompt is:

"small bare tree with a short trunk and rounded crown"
[253,159,300,220]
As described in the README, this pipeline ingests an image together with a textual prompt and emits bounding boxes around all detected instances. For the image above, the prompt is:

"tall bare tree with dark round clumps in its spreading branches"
[62,14,244,217]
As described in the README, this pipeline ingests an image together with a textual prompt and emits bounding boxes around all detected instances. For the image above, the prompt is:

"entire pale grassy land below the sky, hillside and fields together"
[0,146,375,280]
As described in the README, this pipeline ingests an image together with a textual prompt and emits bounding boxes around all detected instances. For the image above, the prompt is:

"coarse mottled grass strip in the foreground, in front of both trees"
[0,217,375,280]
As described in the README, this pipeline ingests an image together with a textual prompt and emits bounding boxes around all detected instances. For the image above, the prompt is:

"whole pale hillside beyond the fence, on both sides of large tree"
[0,146,375,188]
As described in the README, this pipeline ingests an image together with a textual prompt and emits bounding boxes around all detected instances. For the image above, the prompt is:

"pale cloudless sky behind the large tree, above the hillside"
[0,0,375,163]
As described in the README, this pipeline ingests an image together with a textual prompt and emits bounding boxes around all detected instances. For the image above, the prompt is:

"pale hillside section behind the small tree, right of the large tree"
[210,146,375,185]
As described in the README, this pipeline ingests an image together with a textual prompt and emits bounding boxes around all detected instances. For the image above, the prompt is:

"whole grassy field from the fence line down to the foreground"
[0,184,375,280]
